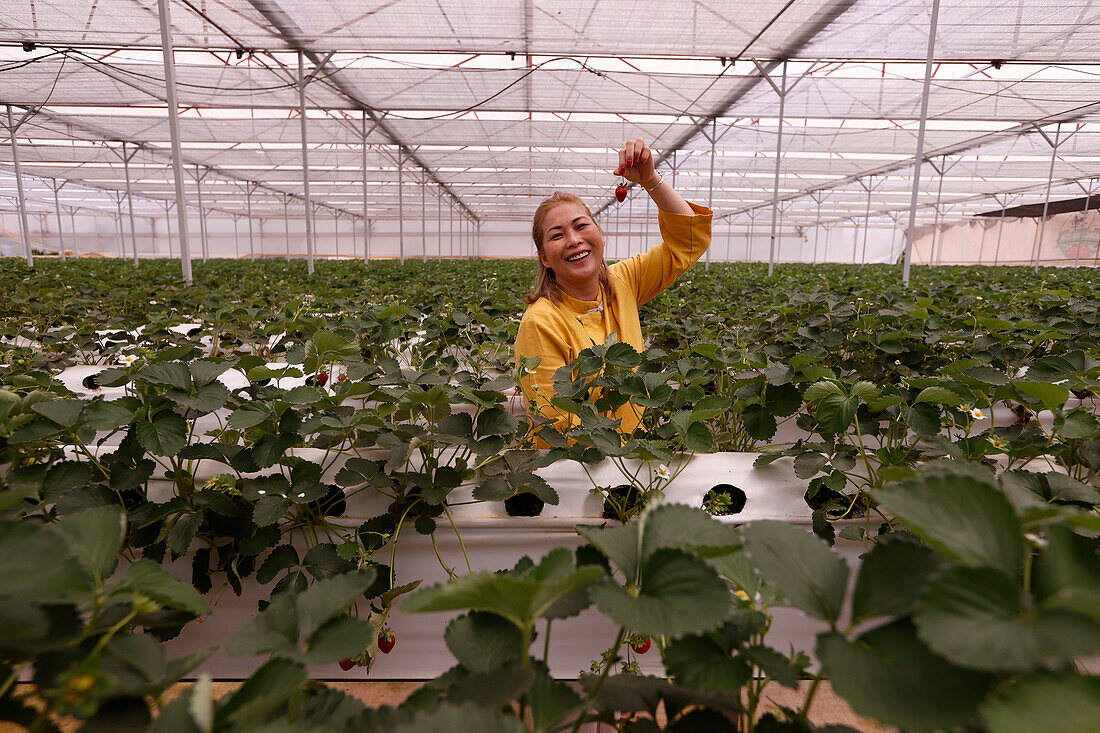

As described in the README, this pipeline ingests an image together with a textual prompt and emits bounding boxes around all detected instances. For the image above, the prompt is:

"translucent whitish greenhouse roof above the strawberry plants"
[0,0,1100,223]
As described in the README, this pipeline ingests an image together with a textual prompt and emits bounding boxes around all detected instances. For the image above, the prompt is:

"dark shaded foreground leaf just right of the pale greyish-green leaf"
[851,541,943,622]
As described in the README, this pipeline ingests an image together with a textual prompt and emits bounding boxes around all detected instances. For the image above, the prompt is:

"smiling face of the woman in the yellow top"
[539,201,604,300]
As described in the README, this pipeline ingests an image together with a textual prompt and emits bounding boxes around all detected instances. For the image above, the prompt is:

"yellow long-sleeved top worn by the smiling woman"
[516,204,713,447]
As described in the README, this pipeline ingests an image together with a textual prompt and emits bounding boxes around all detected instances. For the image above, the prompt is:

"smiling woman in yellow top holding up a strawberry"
[516,138,712,435]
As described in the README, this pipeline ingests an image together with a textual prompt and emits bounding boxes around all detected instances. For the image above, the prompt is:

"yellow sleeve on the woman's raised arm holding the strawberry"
[614,201,714,306]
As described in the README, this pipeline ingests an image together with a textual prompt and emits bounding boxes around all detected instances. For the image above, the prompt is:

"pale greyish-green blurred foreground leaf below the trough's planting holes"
[741,522,848,625]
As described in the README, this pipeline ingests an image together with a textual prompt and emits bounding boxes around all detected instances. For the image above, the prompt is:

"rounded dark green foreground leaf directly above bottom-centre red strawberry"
[589,549,730,636]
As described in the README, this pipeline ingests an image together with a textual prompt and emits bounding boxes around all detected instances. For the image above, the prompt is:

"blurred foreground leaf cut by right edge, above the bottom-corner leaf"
[1035,525,1100,622]
